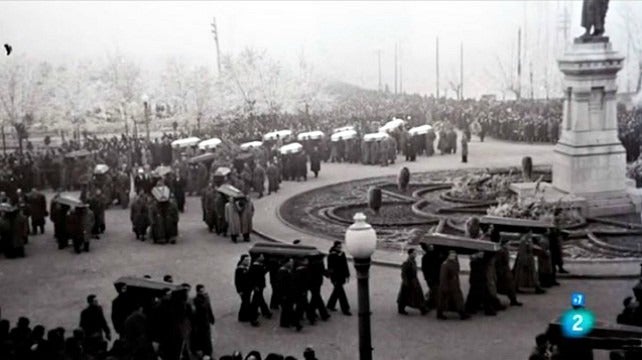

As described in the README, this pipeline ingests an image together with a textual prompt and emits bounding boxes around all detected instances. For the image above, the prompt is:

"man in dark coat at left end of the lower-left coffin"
[80,294,111,354]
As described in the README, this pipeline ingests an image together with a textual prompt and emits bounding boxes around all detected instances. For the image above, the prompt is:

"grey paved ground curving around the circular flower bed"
[0,140,639,360]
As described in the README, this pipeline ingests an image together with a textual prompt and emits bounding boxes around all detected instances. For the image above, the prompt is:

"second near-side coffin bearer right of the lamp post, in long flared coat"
[437,251,469,320]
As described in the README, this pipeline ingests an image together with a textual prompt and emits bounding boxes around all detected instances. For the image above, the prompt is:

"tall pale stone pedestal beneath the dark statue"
[553,41,635,216]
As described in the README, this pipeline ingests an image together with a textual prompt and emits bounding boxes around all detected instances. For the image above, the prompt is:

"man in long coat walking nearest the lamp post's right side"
[397,249,428,315]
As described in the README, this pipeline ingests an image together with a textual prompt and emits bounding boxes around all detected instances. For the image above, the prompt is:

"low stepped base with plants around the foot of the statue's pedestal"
[510,182,642,217]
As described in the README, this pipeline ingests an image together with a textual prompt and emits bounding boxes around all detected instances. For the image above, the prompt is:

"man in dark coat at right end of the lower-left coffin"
[192,284,215,357]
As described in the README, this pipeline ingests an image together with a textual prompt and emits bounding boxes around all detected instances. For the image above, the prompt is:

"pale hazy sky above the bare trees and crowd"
[0,0,642,95]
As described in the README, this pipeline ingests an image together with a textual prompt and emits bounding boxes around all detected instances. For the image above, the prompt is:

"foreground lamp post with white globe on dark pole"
[345,213,377,360]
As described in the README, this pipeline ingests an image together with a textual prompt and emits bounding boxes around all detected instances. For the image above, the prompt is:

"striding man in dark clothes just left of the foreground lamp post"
[328,241,352,316]
